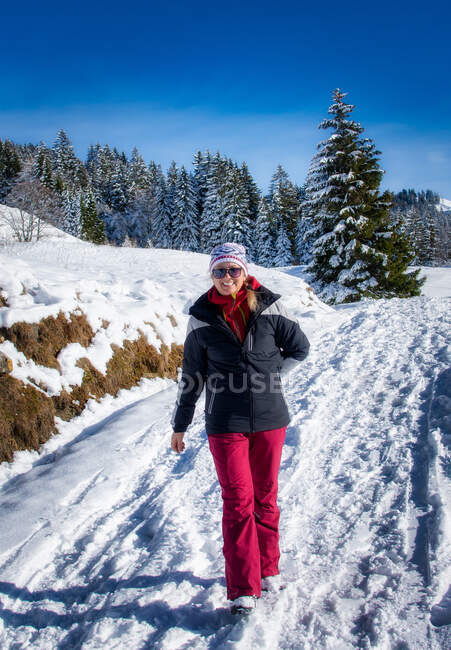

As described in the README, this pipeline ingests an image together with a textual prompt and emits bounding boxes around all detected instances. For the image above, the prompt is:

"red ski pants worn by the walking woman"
[208,427,286,600]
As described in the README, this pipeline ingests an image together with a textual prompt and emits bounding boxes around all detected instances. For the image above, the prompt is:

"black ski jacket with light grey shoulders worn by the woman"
[172,286,310,434]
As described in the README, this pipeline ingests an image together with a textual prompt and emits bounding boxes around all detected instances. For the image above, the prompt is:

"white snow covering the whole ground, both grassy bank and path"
[0,232,451,650]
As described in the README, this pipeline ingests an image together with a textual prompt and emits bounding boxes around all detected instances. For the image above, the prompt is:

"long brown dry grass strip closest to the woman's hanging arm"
[52,335,183,420]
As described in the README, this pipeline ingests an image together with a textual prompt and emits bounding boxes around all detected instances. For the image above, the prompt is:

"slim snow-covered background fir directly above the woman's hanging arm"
[173,166,199,251]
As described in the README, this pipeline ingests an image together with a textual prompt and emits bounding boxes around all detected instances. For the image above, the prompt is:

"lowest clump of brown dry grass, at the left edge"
[0,375,55,462]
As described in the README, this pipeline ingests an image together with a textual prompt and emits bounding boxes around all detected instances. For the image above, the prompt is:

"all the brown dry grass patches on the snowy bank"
[0,313,183,462]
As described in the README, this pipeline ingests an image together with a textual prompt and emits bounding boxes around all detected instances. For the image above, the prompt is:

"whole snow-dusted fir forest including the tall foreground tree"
[0,90,450,302]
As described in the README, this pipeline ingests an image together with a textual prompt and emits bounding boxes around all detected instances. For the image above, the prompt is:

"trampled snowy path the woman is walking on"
[0,298,451,650]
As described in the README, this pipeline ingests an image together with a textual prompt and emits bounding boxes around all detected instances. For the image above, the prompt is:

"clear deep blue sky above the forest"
[0,0,451,198]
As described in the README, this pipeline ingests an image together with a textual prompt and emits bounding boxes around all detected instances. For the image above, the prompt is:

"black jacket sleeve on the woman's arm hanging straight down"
[171,316,207,433]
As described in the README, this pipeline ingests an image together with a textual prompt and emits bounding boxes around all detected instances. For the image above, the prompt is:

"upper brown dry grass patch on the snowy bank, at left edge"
[0,312,94,369]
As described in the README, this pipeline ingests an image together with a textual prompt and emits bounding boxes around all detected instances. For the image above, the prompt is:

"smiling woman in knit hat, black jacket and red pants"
[171,243,309,613]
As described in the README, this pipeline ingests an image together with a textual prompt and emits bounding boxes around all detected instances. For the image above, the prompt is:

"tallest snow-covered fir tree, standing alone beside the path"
[306,89,421,302]
